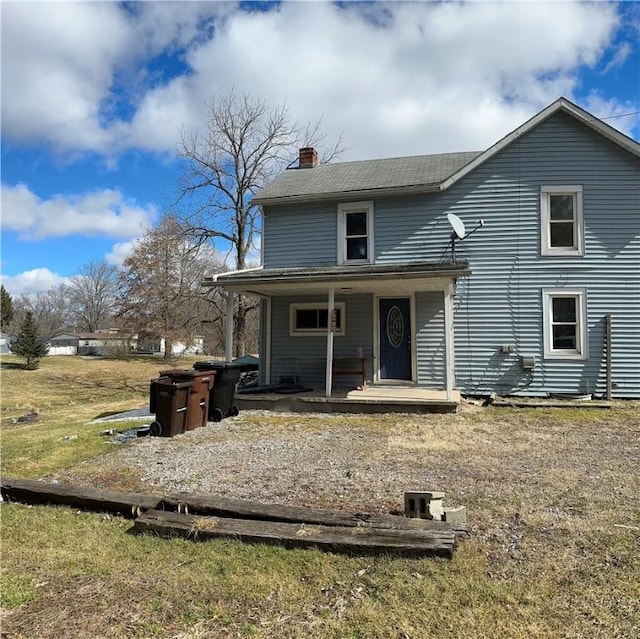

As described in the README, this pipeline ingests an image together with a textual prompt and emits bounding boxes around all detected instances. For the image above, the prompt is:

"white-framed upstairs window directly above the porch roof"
[338,202,373,264]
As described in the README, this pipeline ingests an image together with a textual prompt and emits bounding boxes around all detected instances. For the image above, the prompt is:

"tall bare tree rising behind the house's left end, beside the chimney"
[179,90,341,355]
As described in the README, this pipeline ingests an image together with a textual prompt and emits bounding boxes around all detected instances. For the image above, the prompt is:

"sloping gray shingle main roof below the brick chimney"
[253,151,480,204]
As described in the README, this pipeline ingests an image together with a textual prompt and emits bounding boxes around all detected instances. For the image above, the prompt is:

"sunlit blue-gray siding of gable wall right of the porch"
[444,114,640,398]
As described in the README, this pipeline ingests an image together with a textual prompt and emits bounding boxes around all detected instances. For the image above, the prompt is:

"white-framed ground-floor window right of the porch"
[543,289,587,359]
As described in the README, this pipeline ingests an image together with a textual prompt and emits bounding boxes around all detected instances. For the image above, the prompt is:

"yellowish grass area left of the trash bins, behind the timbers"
[0,355,188,477]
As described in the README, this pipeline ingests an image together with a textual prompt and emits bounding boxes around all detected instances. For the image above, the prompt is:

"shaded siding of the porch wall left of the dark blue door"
[271,295,373,389]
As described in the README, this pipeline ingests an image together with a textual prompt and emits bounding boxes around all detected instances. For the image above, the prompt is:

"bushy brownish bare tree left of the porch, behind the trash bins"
[115,216,220,359]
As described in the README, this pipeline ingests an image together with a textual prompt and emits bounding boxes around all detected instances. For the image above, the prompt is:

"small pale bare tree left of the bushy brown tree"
[69,260,118,333]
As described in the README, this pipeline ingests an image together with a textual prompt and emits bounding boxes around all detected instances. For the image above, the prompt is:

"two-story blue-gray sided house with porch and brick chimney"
[208,98,640,398]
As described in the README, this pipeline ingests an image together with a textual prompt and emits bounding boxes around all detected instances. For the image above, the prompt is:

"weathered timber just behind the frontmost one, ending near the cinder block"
[161,493,468,534]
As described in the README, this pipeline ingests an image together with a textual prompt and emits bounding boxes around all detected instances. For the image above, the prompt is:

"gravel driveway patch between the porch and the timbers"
[63,411,458,512]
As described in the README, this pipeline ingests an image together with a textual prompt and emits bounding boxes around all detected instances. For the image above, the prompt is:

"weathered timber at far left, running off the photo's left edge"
[0,477,161,517]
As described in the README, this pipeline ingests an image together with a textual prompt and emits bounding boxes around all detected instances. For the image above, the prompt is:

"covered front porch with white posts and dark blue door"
[203,263,470,404]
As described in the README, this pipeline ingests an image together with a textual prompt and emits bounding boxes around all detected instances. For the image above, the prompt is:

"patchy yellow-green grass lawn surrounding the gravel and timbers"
[0,356,640,639]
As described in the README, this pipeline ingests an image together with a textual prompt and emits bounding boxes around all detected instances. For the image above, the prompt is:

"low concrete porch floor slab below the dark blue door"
[235,387,460,413]
